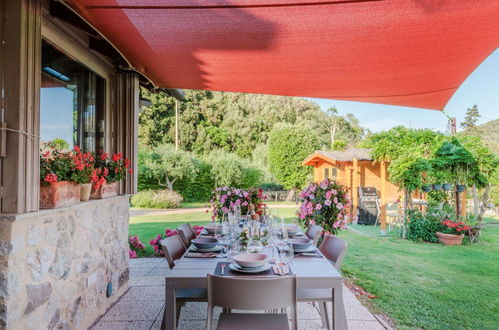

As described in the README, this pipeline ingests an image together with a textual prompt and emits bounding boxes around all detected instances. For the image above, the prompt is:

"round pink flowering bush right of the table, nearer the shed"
[298,180,350,235]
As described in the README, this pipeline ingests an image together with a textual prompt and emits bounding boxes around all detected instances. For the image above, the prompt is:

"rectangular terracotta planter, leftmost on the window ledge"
[40,181,80,209]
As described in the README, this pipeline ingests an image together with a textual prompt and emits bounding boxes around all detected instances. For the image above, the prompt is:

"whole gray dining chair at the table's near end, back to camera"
[206,274,298,330]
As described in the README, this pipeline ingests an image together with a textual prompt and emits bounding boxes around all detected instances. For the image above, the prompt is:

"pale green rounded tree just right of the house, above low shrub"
[139,144,197,190]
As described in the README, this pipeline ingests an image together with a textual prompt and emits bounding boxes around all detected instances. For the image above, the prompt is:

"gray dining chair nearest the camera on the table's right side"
[297,235,348,330]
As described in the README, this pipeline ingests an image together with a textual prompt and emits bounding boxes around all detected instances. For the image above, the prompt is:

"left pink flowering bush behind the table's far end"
[210,186,266,221]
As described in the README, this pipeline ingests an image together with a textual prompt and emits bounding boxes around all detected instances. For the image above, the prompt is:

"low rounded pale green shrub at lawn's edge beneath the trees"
[132,190,183,209]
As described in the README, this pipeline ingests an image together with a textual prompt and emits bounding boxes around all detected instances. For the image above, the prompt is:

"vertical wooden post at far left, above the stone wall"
[0,0,41,213]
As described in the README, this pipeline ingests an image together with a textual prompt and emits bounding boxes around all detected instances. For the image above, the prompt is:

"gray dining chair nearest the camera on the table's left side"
[160,235,208,324]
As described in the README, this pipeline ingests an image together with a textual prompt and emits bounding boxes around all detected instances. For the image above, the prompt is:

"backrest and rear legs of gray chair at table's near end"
[208,274,297,329]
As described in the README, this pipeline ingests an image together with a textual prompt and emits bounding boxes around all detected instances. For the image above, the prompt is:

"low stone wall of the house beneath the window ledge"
[0,196,129,329]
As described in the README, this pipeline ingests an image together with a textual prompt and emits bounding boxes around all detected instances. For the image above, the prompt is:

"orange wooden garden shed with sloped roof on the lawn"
[303,148,401,218]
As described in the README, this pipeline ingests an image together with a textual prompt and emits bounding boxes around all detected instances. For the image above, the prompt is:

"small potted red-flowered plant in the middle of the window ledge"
[72,146,94,202]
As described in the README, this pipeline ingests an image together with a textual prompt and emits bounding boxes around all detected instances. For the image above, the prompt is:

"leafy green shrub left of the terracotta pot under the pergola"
[406,209,444,243]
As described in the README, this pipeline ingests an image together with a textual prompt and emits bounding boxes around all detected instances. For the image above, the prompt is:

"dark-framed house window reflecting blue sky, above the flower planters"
[40,41,105,151]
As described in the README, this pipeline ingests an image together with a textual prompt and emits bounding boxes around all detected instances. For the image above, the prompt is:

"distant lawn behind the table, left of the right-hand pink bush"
[129,206,297,255]
